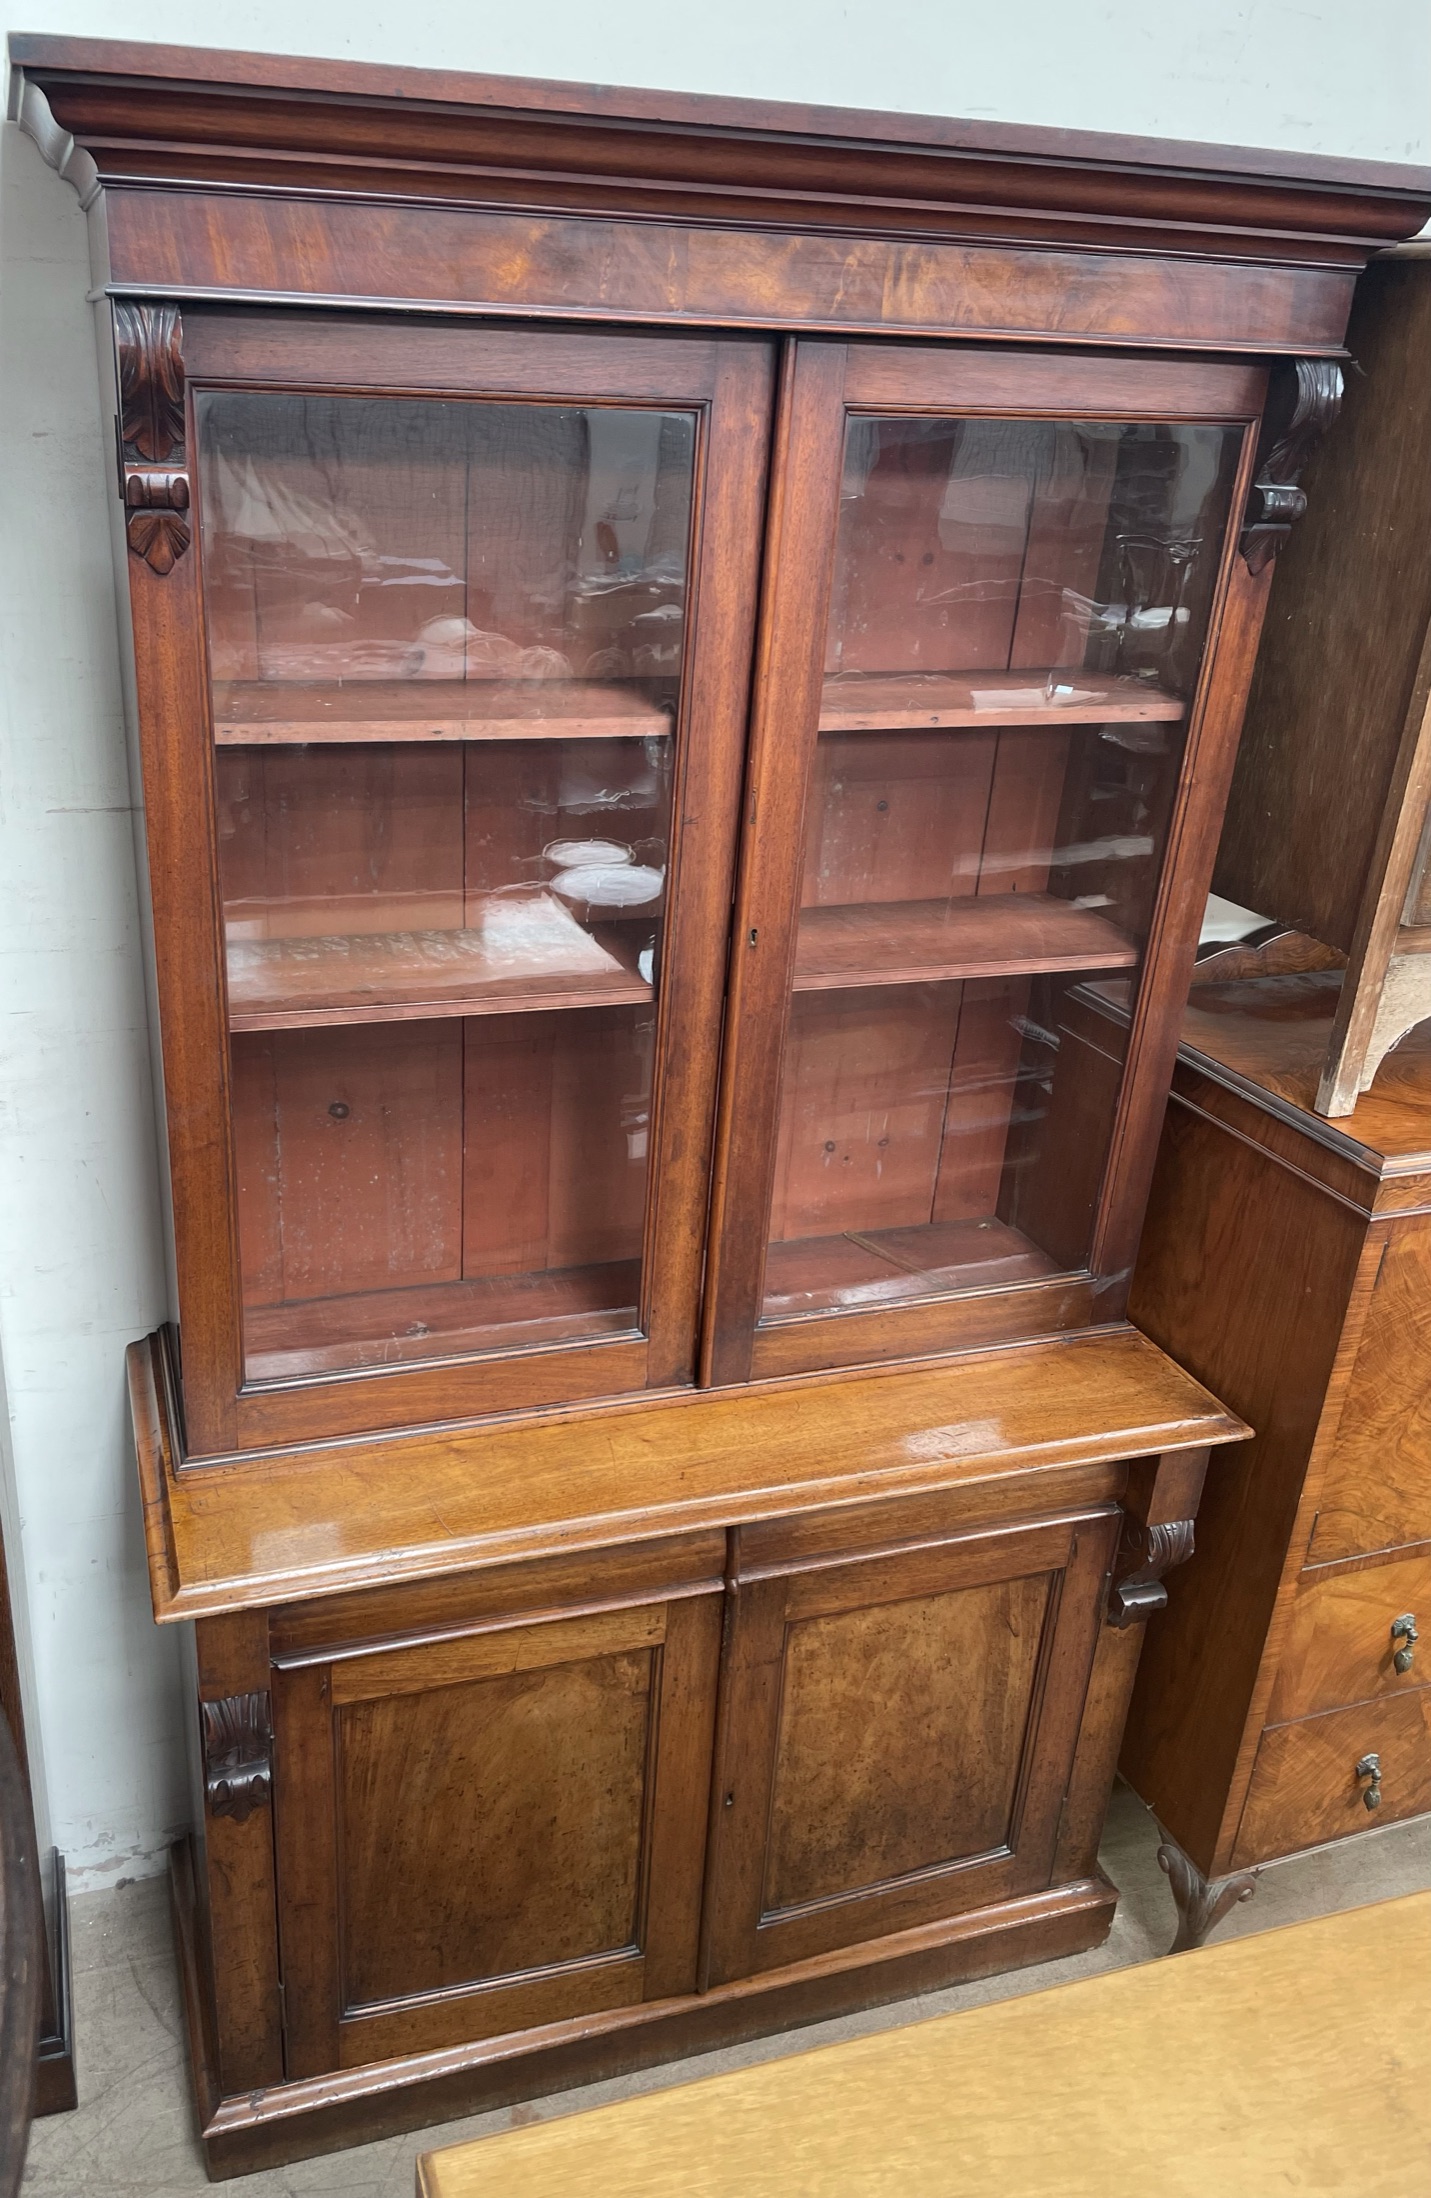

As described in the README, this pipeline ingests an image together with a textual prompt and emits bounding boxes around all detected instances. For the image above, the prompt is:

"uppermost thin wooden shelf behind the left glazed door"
[213,679,675,747]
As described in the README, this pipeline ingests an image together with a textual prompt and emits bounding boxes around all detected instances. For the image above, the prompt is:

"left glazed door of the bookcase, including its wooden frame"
[132,312,772,1453]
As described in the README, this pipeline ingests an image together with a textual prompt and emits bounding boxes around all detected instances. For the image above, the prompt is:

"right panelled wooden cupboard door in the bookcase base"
[706,1512,1117,1983]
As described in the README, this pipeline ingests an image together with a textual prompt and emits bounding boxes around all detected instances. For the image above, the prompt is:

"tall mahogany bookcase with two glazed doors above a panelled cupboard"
[11,37,1431,2176]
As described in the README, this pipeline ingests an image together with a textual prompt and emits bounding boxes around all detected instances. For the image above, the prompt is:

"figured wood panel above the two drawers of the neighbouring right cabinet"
[1308,1213,1431,1565]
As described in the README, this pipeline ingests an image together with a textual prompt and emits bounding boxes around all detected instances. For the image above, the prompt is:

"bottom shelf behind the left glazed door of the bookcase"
[244,1259,642,1380]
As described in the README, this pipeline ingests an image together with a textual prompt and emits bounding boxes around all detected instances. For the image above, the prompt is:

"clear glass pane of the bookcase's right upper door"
[765,418,1242,1319]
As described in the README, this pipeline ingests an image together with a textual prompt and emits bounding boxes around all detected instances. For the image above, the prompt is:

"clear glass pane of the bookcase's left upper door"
[198,393,695,1380]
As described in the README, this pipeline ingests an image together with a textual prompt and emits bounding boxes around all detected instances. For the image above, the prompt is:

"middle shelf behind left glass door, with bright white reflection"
[229,892,651,1031]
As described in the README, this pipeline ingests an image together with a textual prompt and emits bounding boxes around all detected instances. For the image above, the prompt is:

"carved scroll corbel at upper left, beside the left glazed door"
[114,299,191,578]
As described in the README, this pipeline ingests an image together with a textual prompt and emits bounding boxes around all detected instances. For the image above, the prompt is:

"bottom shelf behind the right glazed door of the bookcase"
[763,1215,1060,1321]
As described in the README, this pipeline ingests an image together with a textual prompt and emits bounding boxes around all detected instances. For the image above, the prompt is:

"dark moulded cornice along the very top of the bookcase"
[9,33,1431,266]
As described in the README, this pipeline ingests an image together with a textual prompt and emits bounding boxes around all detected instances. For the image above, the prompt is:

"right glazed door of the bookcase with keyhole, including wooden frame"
[706,343,1264,1380]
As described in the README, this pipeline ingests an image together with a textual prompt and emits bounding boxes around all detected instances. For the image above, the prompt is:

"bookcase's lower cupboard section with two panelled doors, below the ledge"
[176,1451,1207,2174]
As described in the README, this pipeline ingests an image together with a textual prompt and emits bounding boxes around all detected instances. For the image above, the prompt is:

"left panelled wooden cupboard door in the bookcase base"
[273,1594,721,2077]
